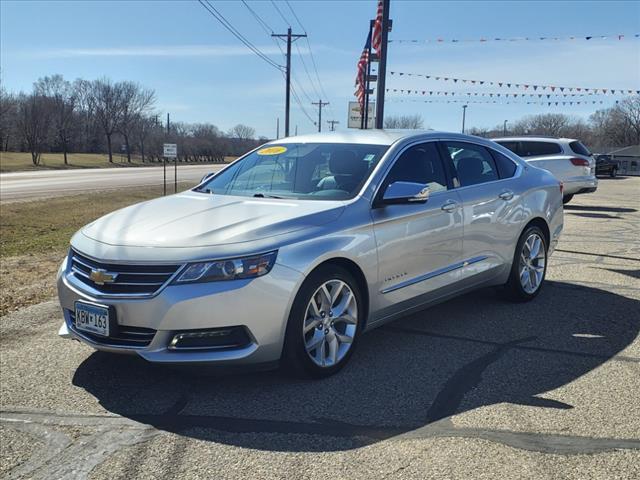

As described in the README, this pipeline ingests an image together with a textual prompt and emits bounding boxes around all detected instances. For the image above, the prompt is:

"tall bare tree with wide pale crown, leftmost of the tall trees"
[34,75,78,165]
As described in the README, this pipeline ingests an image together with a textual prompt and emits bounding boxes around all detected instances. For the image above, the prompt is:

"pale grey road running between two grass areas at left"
[0,165,222,202]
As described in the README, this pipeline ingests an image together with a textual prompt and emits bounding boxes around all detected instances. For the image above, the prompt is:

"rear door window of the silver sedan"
[444,142,500,187]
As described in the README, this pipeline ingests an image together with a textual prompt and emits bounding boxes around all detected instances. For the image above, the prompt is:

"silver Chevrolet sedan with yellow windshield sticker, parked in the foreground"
[58,130,563,377]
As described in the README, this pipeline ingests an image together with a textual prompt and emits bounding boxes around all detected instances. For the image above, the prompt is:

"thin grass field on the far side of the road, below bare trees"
[0,152,236,173]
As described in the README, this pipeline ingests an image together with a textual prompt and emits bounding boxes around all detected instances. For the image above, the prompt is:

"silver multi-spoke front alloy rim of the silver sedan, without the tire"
[302,279,358,368]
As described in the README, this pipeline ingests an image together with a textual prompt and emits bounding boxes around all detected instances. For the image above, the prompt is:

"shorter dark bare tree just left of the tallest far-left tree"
[17,93,51,166]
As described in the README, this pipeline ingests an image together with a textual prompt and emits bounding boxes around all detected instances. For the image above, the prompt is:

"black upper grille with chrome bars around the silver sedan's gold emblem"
[71,250,180,295]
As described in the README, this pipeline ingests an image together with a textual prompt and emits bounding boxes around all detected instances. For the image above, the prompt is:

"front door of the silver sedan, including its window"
[371,142,463,322]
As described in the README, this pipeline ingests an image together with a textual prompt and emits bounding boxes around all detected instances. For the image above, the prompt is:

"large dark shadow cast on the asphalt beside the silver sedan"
[73,282,640,451]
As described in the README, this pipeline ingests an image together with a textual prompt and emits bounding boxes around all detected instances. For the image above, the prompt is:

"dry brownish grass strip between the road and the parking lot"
[0,184,192,316]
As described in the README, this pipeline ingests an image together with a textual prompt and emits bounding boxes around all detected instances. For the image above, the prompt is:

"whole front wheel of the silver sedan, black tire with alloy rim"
[283,265,365,378]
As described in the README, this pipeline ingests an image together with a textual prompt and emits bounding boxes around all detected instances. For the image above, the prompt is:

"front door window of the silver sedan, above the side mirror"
[384,142,447,192]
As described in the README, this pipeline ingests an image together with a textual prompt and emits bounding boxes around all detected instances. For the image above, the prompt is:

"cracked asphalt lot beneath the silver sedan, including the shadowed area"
[0,178,640,480]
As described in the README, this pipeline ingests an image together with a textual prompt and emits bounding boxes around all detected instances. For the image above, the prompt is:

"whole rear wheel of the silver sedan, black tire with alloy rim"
[504,225,548,302]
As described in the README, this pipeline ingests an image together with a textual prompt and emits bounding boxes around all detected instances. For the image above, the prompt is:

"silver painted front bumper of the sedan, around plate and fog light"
[58,263,303,366]
